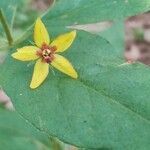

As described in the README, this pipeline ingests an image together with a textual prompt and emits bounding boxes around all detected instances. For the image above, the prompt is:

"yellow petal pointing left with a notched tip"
[12,46,39,61]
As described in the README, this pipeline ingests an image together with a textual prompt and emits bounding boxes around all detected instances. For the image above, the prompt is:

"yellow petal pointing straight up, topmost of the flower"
[34,18,50,48]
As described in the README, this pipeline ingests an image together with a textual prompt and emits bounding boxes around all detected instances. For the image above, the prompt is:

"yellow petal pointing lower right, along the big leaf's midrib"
[51,54,78,79]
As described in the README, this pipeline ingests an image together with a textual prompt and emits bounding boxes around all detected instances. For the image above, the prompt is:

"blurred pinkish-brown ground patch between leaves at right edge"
[125,12,150,65]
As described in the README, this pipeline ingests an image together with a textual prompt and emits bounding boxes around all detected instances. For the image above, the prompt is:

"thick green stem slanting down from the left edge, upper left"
[0,9,13,45]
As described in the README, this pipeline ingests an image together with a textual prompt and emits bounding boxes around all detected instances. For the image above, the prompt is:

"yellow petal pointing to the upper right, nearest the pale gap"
[51,31,76,52]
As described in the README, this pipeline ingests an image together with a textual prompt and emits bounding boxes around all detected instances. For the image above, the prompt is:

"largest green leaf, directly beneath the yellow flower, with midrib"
[0,32,150,150]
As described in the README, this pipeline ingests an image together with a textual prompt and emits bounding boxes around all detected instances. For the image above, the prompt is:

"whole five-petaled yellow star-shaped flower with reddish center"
[12,18,78,89]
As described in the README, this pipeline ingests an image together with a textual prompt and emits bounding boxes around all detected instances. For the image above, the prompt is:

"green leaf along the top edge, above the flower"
[44,0,150,33]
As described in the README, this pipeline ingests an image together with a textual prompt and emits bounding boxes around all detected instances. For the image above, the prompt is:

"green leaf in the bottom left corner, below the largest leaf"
[0,108,51,150]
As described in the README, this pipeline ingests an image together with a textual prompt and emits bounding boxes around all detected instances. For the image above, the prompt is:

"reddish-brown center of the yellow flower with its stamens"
[37,44,57,63]
